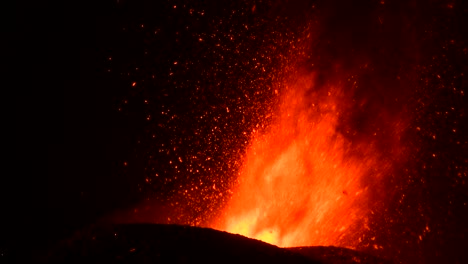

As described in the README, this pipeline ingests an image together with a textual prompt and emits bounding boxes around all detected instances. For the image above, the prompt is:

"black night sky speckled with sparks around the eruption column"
[1,0,468,261]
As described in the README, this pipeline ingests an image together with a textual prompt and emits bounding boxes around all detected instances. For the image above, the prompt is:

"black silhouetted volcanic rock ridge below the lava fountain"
[30,224,392,263]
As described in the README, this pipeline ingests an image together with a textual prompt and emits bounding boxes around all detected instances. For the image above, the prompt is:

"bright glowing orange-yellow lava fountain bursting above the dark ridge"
[214,74,406,248]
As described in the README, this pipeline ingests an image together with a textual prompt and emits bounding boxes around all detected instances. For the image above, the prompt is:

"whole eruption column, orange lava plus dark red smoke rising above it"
[214,0,417,252]
